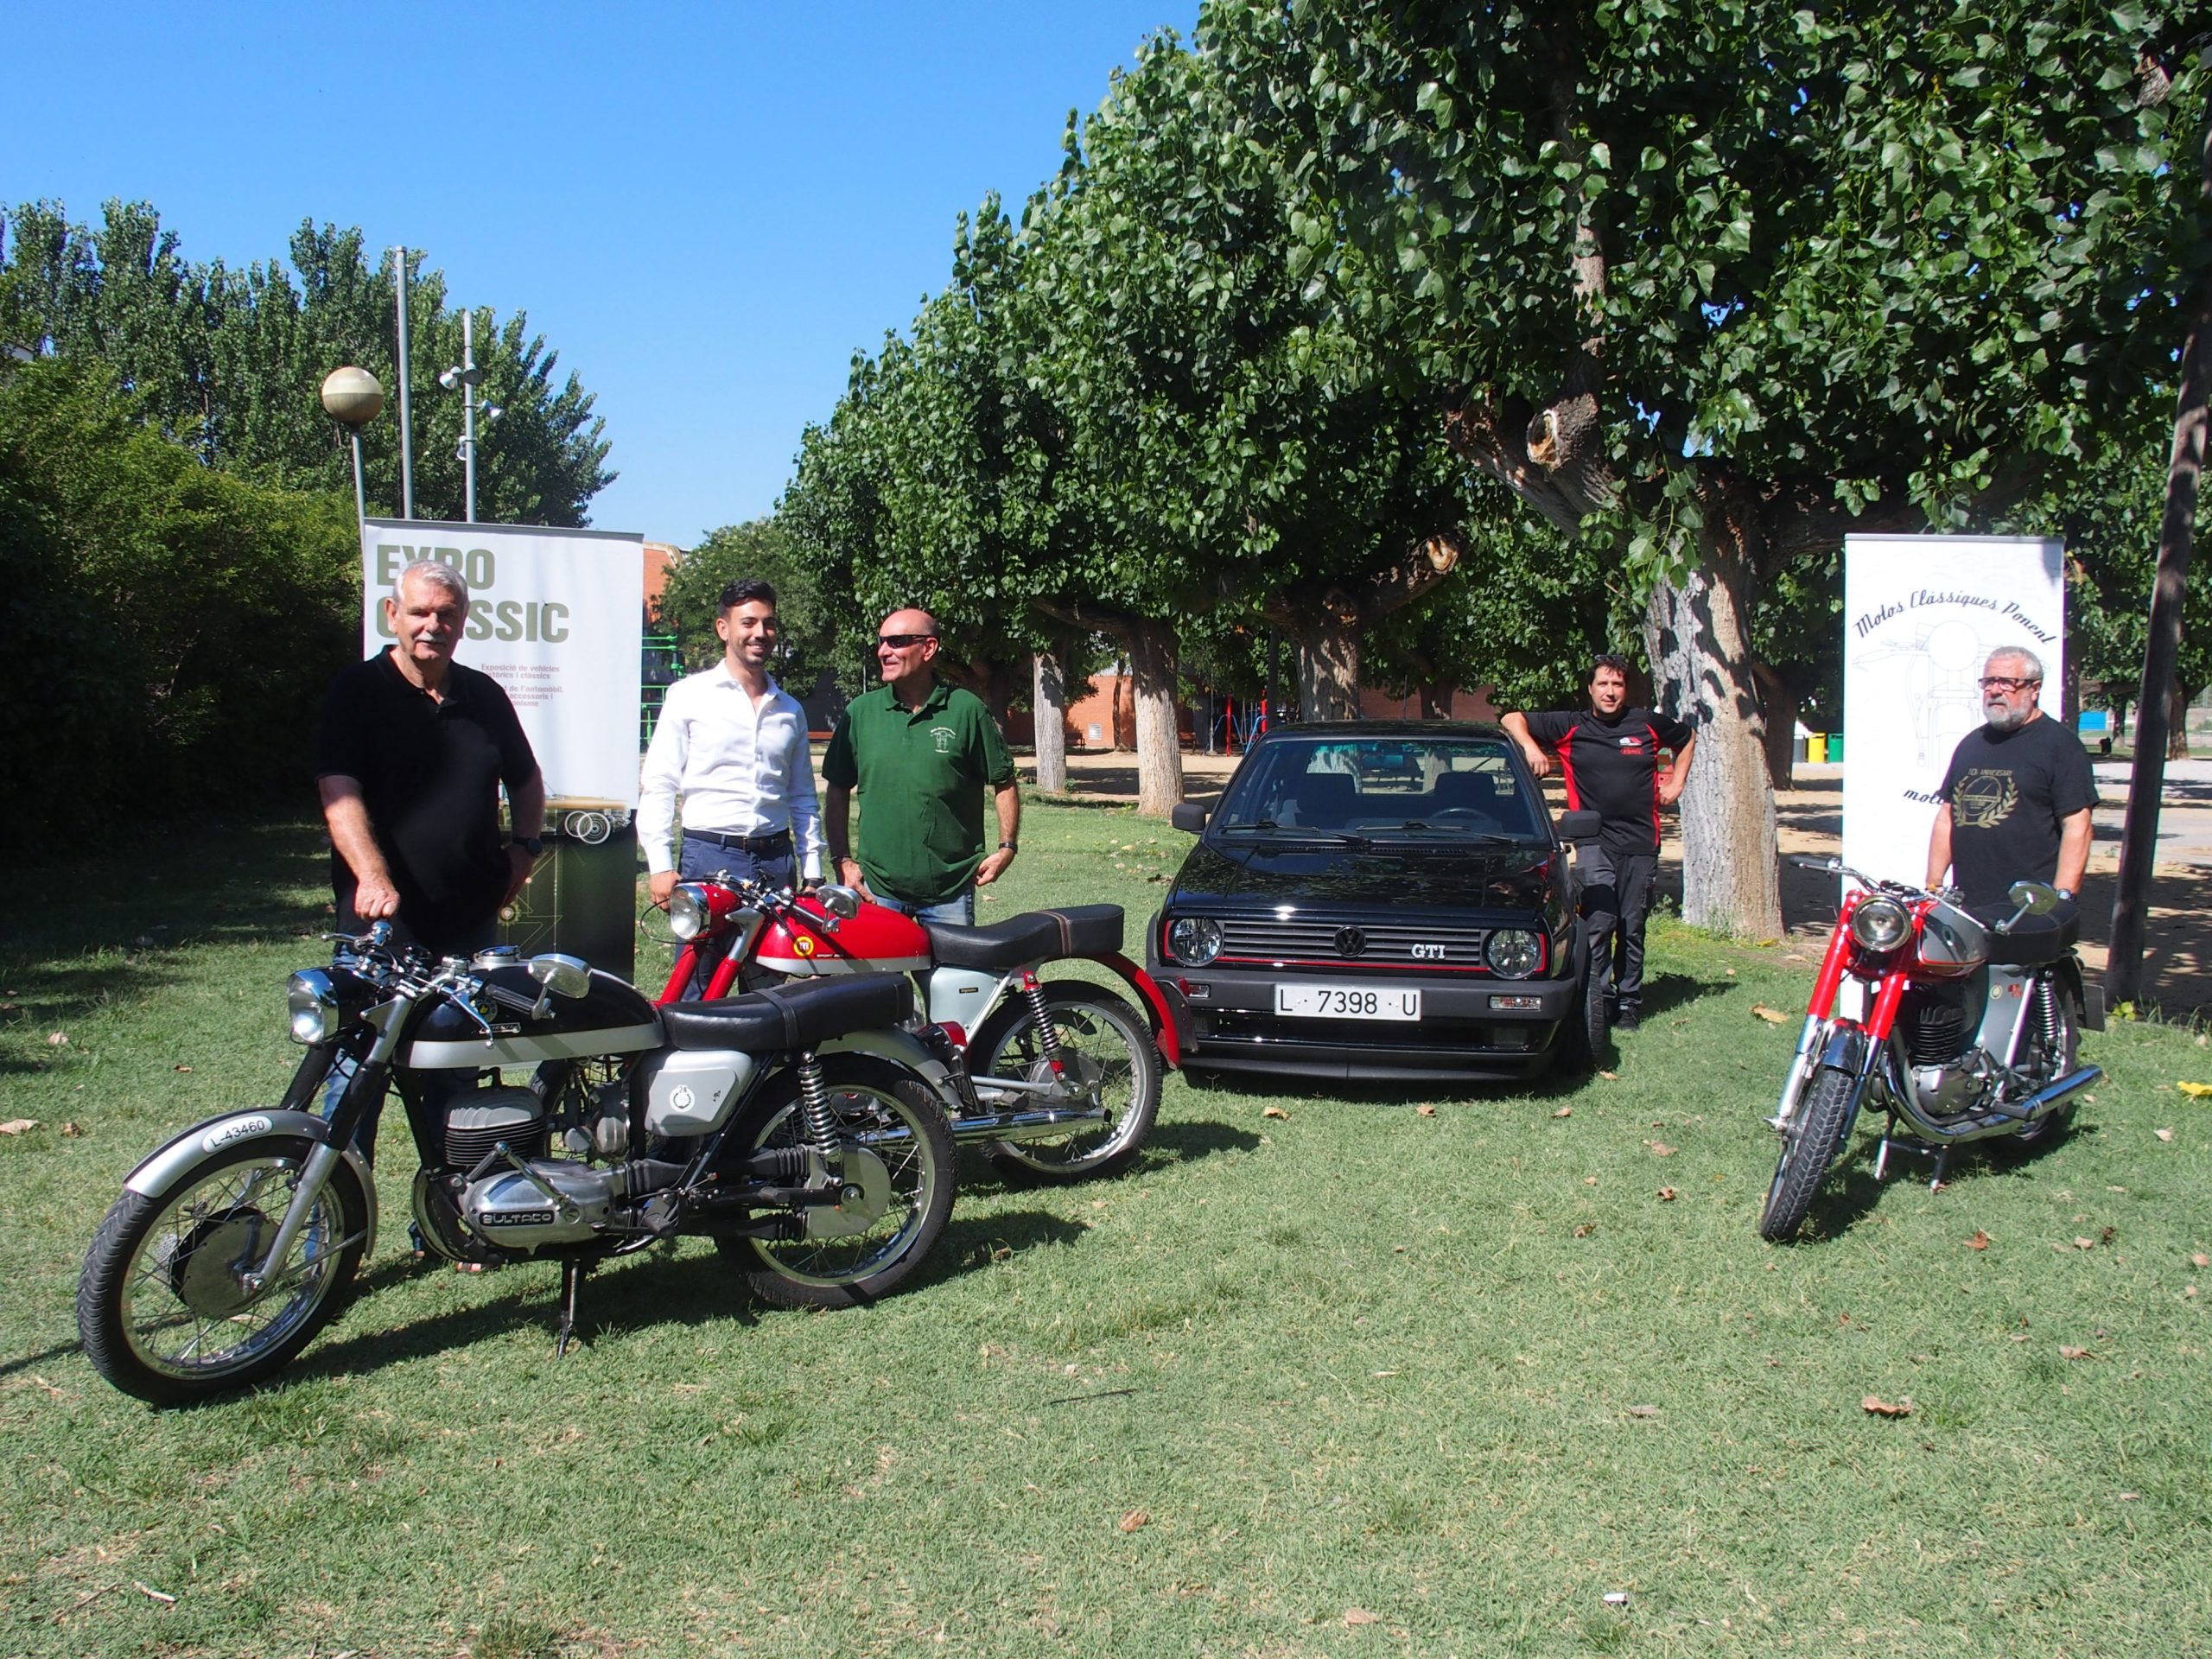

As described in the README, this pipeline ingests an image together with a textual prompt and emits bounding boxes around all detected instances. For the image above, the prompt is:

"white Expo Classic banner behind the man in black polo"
[360,518,646,807]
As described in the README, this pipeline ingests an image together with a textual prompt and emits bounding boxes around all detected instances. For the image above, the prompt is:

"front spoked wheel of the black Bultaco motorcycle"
[78,1137,370,1405]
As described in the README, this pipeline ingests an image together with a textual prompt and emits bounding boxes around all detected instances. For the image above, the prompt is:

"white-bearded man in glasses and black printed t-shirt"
[1927,646,2097,915]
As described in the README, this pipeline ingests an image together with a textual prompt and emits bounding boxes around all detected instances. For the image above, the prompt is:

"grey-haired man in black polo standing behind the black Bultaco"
[315,560,546,1154]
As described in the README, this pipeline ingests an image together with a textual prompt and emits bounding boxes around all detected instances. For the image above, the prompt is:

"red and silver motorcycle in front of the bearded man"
[1758,858,2104,1241]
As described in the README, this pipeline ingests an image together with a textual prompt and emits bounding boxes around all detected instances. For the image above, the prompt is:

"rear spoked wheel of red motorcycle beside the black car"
[969,980,1161,1181]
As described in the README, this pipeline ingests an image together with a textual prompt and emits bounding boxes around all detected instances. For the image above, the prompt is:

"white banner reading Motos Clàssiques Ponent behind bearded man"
[1842,536,2066,882]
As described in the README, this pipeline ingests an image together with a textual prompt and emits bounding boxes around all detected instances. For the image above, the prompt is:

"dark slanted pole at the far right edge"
[2104,115,2212,1002]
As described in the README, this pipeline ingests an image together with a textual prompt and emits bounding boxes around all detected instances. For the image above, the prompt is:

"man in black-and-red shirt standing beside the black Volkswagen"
[1504,655,1697,1031]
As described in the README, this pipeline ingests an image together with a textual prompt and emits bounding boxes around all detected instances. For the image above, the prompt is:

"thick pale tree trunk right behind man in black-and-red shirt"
[1643,539,1783,940]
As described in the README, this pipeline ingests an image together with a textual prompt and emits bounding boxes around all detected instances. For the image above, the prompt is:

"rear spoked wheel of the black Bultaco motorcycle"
[716,1055,953,1307]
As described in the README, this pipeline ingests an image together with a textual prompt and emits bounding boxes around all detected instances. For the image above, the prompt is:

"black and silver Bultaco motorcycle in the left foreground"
[78,923,953,1405]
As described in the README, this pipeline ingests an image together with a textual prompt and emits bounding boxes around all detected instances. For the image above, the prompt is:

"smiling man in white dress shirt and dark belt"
[637,580,823,905]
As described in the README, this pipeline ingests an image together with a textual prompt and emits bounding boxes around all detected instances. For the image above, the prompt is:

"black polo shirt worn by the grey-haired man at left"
[315,648,537,951]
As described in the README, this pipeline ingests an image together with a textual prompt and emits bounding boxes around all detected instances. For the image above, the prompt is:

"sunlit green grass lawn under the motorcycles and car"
[0,805,2212,1659]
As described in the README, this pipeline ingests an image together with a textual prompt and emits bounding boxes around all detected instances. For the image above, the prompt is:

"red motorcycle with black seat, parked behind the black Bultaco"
[661,876,1179,1181]
